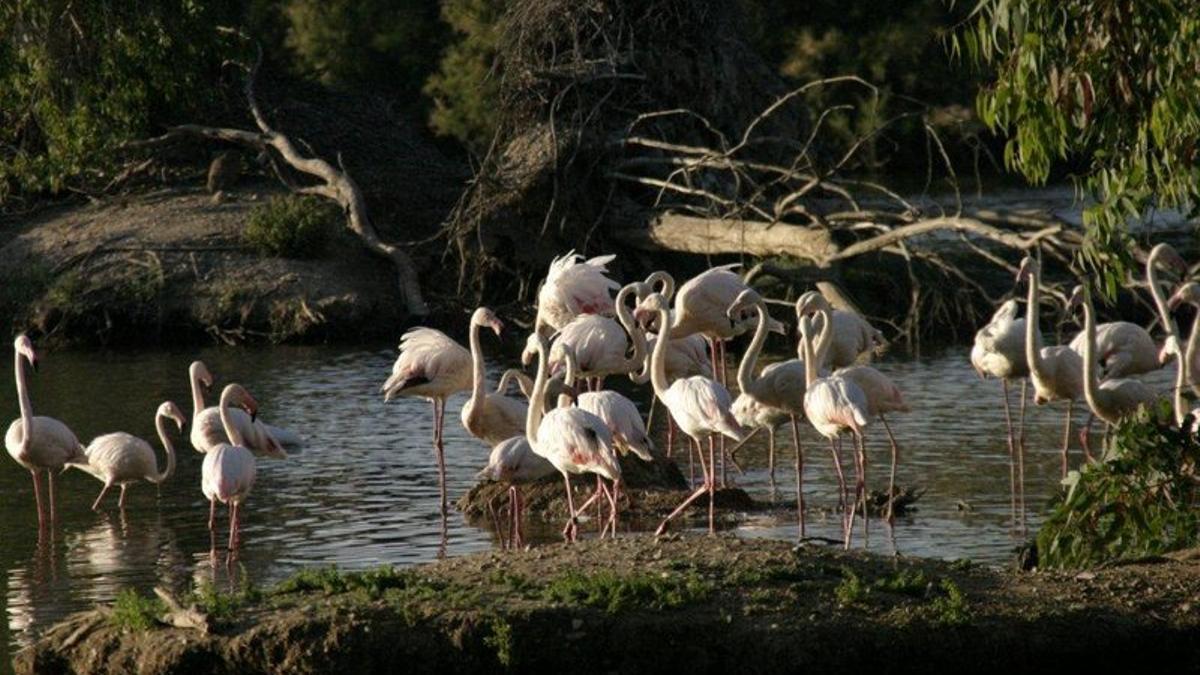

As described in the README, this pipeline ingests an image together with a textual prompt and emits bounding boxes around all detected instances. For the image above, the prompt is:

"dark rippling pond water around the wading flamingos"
[0,347,1172,663]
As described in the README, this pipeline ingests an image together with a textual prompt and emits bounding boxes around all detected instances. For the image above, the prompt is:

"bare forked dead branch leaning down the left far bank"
[122,40,430,316]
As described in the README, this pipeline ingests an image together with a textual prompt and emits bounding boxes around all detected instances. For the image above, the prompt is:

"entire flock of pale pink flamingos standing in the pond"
[5,244,1200,550]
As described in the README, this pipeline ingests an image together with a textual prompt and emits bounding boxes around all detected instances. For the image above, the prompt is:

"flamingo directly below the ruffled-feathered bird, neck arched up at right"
[550,277,646,389]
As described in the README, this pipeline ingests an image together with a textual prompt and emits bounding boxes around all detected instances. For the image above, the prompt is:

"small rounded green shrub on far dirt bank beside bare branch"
[242,195,338,258]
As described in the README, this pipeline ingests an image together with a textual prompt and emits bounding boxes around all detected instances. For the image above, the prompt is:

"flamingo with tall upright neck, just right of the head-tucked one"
[1016,256,1084,478]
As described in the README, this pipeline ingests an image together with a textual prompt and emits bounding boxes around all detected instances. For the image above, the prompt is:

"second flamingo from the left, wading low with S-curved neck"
[67,401,187,510]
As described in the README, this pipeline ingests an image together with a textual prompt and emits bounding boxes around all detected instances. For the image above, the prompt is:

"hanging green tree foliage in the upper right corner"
[950,0,1200,295]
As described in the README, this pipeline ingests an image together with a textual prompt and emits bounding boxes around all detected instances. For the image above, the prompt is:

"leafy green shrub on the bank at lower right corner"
[1037,405,1200,568]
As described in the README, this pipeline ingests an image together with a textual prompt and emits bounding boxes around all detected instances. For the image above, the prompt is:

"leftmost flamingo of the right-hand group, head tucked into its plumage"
[971,299,1030,520]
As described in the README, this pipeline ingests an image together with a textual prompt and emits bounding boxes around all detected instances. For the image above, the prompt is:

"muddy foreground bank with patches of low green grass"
[16,536,1200,674]
